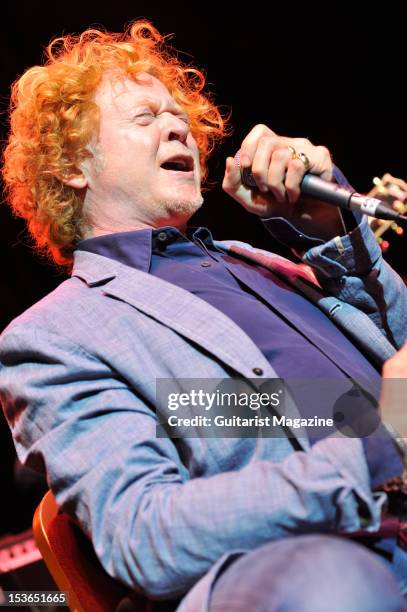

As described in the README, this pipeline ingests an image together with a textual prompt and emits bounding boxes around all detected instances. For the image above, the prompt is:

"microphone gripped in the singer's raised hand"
[235,151,407,221]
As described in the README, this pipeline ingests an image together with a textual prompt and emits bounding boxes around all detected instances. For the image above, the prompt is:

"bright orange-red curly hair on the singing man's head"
[3,20,226,267]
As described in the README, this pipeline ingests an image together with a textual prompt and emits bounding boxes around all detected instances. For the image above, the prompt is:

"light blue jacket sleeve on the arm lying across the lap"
[0,321,384,599]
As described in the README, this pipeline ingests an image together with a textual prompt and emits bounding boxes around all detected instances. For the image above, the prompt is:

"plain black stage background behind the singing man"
[0,0,407,533]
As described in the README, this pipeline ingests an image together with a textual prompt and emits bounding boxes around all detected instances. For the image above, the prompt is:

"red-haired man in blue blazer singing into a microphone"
[0,21,407,612]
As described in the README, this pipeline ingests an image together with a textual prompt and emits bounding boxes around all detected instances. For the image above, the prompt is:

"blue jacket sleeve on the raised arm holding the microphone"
[263,215,407,356]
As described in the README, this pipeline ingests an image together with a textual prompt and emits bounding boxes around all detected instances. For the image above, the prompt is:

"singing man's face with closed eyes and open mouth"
[84,73,202,234]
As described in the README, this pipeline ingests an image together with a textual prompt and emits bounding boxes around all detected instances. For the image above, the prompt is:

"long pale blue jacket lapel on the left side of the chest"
[72,251,277,378]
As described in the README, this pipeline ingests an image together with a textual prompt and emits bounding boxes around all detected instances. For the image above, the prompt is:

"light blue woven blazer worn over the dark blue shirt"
[0,218,407,611]
